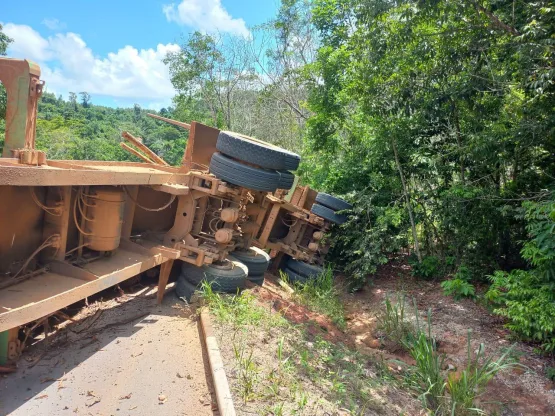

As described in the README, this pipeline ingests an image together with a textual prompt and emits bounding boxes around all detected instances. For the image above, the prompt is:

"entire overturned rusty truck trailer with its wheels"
[0,58,348,364]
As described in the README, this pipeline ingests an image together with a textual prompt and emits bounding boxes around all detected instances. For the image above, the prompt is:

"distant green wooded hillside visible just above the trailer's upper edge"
[0,92,188,165]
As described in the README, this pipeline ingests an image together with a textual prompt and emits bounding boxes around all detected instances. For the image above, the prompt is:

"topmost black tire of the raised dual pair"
[216,131,301,170]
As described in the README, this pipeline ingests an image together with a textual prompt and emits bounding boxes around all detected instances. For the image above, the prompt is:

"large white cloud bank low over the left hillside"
[4,23,179,102]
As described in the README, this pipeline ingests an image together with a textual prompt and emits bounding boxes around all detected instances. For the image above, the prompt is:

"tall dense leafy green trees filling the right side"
[302,0,555,282]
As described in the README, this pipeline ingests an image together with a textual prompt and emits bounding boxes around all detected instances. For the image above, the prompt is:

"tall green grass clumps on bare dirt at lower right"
[378,295,519,416]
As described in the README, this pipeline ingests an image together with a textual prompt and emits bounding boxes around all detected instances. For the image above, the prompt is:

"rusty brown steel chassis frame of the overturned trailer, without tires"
[0,58,327,362]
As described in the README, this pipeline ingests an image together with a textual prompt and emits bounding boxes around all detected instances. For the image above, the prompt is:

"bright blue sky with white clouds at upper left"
[0,0,279,109]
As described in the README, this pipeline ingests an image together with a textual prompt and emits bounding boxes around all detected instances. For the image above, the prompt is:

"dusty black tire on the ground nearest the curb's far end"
[181,260,248,293]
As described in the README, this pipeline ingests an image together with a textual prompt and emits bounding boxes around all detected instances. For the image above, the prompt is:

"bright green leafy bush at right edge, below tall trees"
[486,199,555,352]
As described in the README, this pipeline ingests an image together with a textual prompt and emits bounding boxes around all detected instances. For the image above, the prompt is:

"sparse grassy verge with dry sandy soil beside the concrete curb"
[201,285,420,415]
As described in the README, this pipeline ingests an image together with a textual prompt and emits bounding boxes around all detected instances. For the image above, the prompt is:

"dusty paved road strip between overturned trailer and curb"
[0,293,215,416]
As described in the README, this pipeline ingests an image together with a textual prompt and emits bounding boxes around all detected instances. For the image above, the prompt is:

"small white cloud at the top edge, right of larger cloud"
[162,0,250,37]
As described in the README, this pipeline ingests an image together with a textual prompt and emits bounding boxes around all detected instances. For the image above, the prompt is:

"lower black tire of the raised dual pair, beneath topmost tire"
[210,152,279,192]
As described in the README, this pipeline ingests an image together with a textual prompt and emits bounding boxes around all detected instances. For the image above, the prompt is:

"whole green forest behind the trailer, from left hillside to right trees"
[0,0,555,352]
